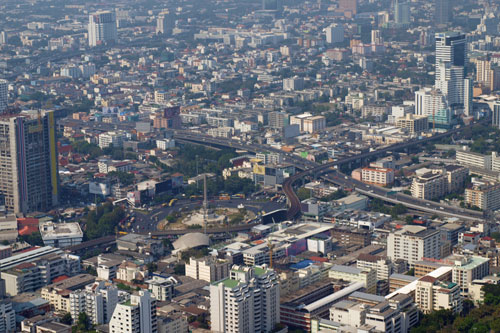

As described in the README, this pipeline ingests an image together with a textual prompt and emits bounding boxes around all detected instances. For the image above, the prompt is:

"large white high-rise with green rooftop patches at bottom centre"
[210,266,280,333]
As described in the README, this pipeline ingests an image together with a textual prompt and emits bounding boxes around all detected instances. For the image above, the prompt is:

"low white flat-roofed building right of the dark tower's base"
[39,222,83,248]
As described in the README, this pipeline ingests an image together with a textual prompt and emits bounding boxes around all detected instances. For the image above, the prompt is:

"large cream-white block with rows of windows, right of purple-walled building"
[387,225,440,266]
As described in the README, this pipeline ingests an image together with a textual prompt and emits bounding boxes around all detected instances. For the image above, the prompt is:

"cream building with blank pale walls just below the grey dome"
[186,257,231,282]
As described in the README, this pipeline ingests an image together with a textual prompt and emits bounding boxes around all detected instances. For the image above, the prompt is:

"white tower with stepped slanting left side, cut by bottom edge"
[109,290,158,333]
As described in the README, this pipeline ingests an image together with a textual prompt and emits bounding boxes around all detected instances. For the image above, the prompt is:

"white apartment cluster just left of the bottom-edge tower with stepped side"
[69,281,118,325]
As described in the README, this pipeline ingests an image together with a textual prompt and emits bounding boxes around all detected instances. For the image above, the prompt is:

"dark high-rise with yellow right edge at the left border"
[0,111,59,214]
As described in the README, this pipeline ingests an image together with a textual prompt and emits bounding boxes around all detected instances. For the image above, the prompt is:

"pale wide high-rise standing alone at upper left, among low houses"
[88,11,117,47]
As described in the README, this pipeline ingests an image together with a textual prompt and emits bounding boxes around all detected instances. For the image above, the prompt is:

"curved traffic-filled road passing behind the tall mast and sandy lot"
[129,199,285,233]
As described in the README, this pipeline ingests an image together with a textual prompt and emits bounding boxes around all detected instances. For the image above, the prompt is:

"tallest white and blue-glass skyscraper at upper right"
[435,32,467,107]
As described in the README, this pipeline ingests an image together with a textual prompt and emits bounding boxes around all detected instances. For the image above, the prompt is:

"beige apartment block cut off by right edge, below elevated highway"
[465,181,500,210]
